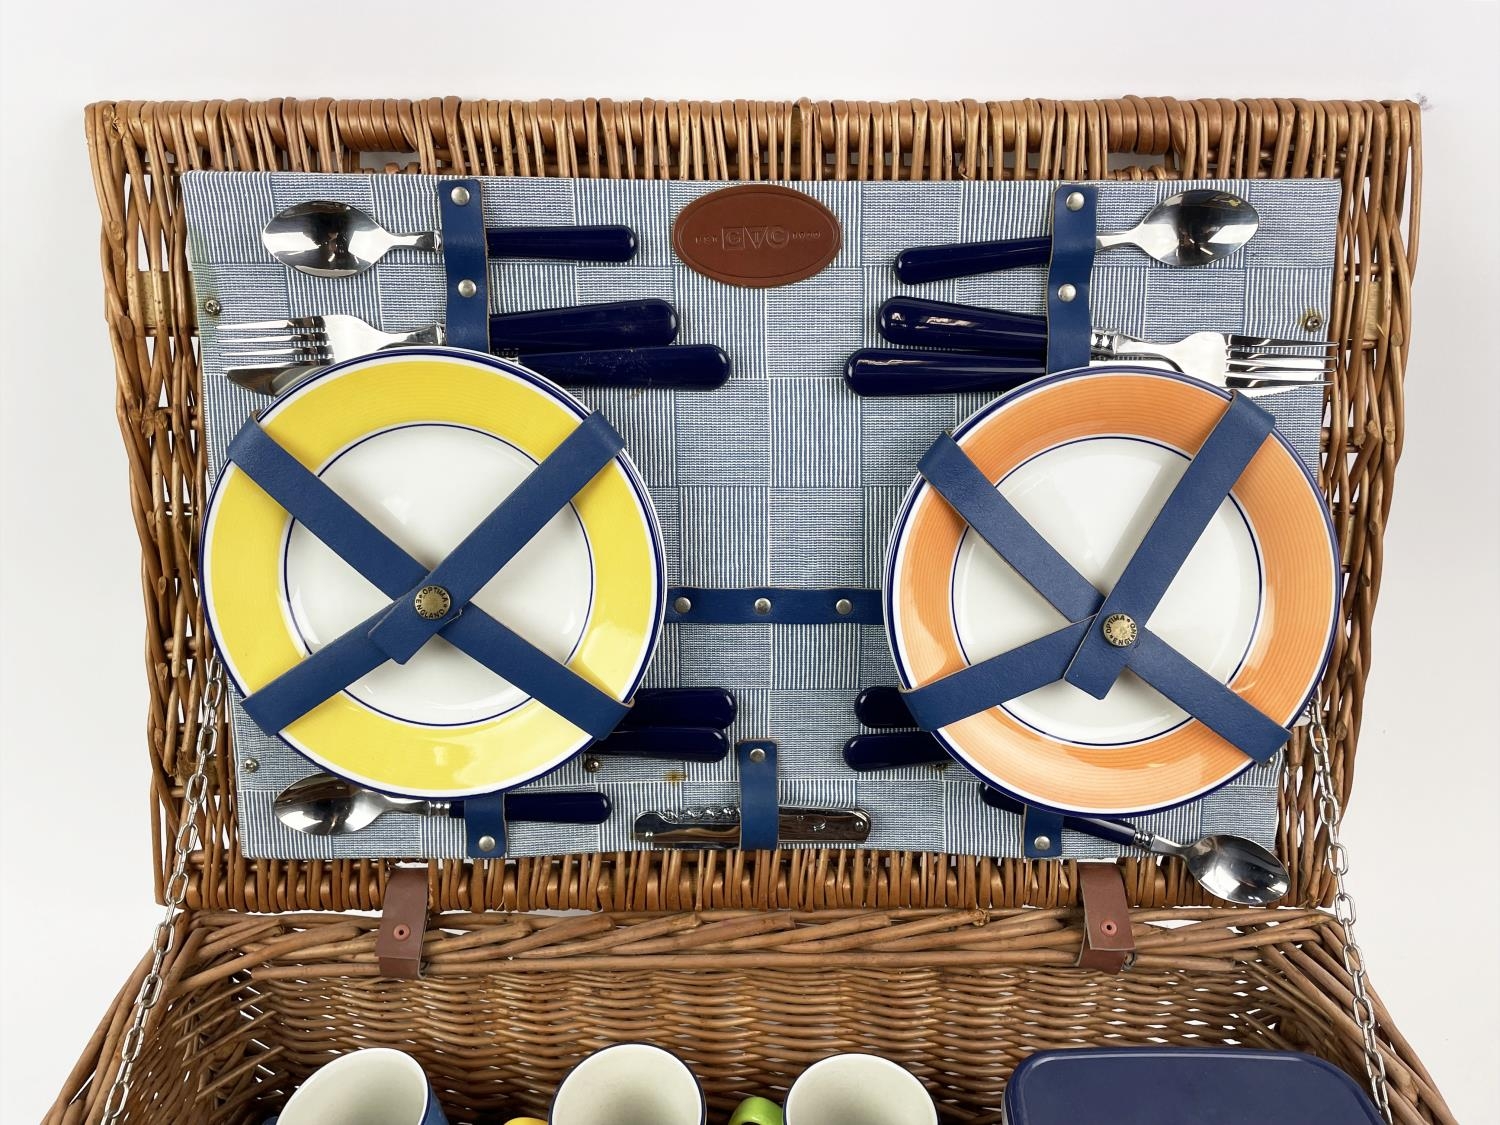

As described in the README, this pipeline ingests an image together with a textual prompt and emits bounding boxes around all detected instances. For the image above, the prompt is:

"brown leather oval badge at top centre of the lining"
[672,183,843,288]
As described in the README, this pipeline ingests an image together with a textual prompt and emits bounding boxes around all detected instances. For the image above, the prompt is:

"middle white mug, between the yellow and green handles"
[548,1043,708,1125]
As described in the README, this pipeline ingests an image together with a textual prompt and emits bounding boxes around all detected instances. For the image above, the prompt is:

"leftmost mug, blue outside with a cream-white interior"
[266,1047,449,1125]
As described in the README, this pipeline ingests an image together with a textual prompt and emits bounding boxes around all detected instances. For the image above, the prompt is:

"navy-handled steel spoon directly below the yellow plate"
[273,774,611,836]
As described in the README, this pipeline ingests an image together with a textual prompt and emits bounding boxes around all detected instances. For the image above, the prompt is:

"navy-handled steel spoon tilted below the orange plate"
[983,786,1290,906]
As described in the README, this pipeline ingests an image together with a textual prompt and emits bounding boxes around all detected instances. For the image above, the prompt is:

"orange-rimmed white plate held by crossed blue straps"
[885,368,1340,816]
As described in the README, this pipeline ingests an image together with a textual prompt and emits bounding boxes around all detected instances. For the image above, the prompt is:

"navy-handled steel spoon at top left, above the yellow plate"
[261,200,636,278]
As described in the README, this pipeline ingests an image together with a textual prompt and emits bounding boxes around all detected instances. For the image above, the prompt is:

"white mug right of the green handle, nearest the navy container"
[786,1055,938,1125]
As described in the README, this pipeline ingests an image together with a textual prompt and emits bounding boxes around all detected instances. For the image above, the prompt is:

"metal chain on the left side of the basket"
[104,654,224,1125]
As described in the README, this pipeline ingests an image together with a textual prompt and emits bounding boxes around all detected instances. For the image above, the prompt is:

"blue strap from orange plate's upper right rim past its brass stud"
[1067,395,1277,699]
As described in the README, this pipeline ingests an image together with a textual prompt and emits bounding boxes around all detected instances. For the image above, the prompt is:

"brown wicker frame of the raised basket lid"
[87,98,1421,911]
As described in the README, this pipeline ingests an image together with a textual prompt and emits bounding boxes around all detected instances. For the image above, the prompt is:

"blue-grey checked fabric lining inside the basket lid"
[183,173,1340,858]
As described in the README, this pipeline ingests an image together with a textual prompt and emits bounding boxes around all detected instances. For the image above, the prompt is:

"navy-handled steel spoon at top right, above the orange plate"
[896,188,1260,285]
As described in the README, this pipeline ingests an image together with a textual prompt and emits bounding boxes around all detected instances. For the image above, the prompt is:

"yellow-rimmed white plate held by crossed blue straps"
[203,348,666,798]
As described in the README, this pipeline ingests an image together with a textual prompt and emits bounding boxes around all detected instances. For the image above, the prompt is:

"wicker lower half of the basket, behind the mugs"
[47,909,1454,1125]
